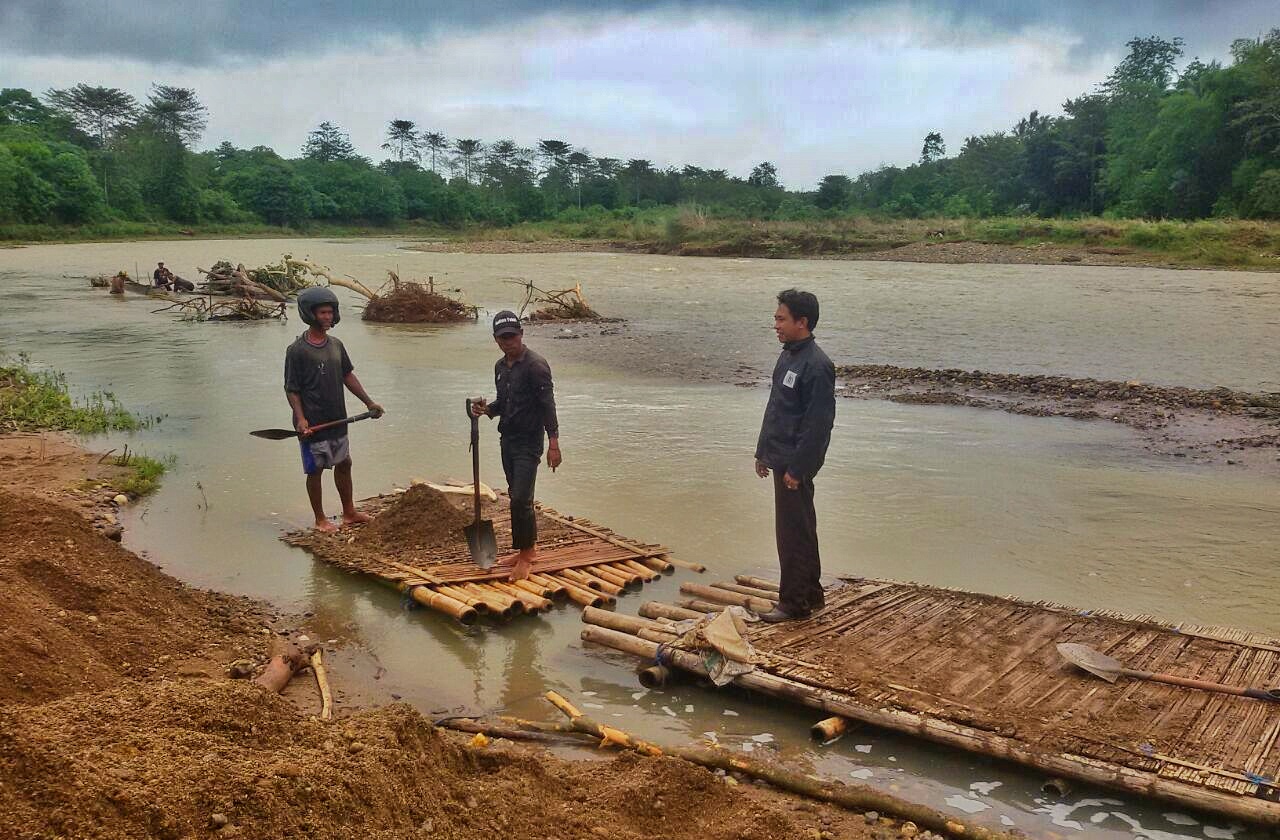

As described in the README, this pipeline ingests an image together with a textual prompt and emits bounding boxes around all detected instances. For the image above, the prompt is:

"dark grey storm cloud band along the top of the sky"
[0,0,1276,65]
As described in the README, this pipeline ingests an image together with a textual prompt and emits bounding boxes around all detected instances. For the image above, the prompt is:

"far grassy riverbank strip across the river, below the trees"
[408,210,1280,271]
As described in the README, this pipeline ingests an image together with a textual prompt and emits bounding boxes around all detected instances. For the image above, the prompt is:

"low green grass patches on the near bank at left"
[0,355,167,496]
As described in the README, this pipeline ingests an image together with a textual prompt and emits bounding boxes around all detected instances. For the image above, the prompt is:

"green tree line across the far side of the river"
[0,29,1280,227]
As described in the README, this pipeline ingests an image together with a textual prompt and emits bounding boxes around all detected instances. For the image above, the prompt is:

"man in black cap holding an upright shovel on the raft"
[471,310,561,580]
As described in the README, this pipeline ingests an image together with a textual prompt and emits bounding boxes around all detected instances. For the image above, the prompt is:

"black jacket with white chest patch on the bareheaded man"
[755,335,836,480]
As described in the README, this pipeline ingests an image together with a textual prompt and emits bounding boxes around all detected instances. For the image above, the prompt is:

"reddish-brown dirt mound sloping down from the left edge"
[0,490,271,703]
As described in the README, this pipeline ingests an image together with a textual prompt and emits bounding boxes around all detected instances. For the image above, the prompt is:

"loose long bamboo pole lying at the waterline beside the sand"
[547,691,1012,840]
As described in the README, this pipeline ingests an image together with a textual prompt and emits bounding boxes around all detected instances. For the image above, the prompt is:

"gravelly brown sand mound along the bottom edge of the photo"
[0,680,861,840]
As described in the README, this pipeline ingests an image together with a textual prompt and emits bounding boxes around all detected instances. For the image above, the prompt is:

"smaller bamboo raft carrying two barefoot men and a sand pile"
[283,493,705,625]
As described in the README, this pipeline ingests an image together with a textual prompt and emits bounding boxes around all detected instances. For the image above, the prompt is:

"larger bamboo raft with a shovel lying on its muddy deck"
[582,575,1280,827]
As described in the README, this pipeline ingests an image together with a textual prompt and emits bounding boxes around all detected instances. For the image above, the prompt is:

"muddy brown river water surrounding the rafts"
[0,239,1280,837]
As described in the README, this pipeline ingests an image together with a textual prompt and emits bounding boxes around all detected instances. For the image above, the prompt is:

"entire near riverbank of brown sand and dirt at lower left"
[0,435,899,840]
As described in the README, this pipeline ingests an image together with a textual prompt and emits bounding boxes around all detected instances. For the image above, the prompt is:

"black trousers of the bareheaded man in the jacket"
[773,470,822,615]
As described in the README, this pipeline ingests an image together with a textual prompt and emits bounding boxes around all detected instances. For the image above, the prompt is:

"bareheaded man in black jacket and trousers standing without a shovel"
[755,289,836,621]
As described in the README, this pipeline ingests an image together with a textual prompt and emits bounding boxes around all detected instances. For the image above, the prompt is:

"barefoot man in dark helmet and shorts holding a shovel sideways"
[284,287,383,531]
